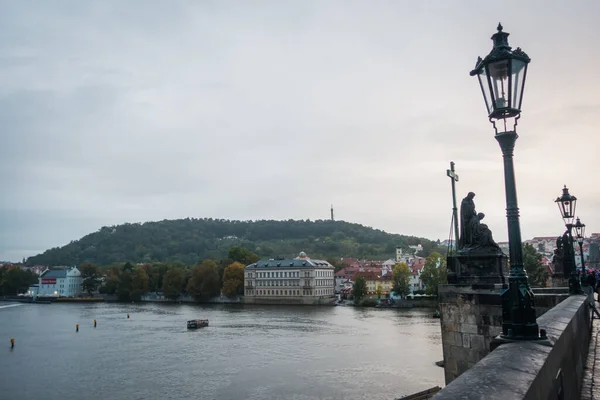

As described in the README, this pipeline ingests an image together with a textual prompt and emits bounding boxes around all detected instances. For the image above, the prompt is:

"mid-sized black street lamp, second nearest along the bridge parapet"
[554,185,583,294]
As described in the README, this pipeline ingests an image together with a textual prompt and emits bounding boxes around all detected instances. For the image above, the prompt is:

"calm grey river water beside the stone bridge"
[0,302,444,400]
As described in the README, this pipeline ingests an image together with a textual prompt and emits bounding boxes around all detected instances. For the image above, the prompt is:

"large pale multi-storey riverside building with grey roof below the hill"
[244,252,335,304]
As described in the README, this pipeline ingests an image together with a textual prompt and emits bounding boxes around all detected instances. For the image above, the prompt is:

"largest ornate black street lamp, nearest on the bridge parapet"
[471,24,546,340]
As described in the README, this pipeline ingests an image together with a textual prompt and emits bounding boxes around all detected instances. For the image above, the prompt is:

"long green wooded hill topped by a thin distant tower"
[26,218,437,266]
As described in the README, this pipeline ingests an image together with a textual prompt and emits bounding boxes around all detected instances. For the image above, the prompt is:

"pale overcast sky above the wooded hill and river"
[0,0,600,261]
